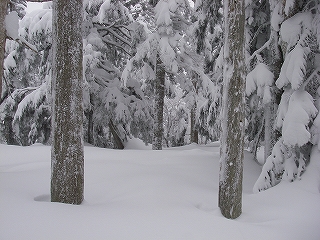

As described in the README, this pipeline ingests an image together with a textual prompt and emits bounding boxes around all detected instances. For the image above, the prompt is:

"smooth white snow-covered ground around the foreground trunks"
[0,141,320,240]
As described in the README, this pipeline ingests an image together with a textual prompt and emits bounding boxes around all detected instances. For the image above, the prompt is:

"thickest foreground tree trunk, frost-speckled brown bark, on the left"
[51,0,84,204]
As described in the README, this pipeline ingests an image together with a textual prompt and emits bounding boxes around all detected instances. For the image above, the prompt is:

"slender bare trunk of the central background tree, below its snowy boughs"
[152,55,166,150]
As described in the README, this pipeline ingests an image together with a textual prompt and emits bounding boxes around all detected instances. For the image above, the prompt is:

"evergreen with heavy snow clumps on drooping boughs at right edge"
[254,1,320,191]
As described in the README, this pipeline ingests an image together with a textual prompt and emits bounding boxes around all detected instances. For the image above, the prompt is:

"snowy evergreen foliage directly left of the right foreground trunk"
[191,0,223,142]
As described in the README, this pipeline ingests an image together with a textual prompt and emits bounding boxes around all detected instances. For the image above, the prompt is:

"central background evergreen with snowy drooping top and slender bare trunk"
[122,0,192,149]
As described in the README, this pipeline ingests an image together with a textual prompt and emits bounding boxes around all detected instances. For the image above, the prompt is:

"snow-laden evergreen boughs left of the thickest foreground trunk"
[0,4,52,145]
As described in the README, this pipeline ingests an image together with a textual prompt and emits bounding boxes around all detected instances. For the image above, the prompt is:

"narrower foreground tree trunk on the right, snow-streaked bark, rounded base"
[219,0,245,219]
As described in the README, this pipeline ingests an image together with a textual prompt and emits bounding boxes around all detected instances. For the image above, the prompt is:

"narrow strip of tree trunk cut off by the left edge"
[0,0,8,100]
